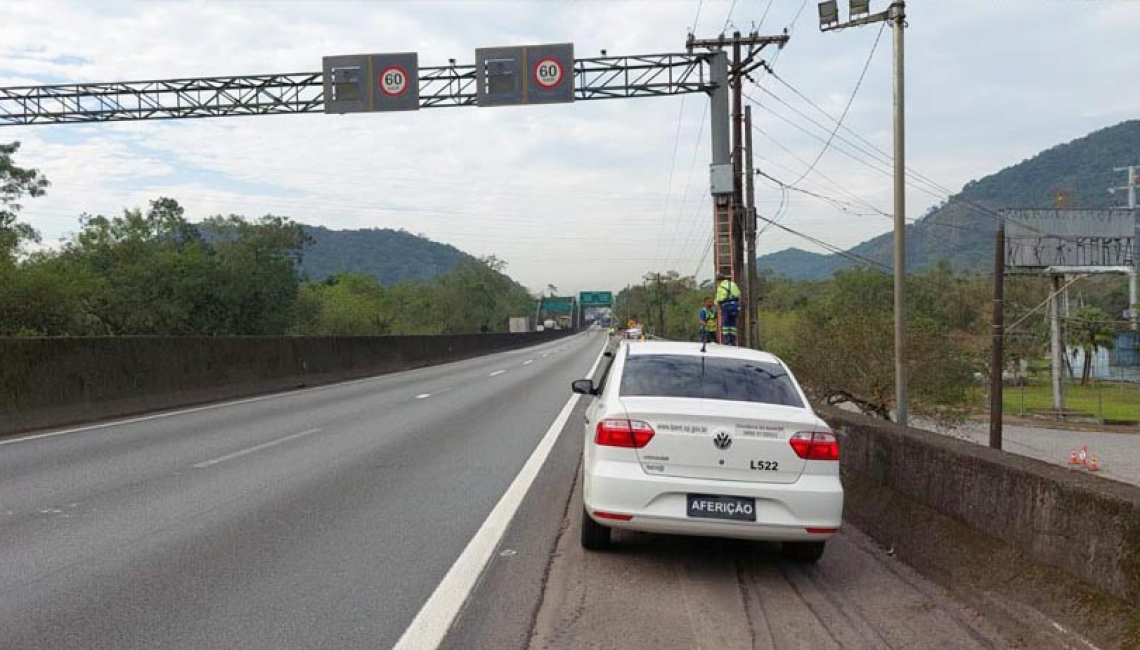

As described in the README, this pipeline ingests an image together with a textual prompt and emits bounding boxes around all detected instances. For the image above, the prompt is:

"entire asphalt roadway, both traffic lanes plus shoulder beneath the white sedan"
[0,334,1112,650]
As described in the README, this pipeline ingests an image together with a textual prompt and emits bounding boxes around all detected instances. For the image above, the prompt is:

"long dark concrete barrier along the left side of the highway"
[0,331,571,434]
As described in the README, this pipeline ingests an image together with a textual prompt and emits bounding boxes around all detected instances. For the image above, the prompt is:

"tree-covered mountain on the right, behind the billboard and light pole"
[757,120,1140,279]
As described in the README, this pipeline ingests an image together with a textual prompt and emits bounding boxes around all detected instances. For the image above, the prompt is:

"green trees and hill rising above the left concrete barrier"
[0,144,534,336]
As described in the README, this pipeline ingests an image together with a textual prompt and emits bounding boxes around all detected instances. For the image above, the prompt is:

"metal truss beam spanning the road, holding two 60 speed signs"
[0,54,714,127]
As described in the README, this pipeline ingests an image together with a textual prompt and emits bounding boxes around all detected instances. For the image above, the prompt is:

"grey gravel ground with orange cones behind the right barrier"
[917,421,1140,486]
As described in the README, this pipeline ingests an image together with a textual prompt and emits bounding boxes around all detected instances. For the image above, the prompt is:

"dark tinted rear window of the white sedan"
[620,355,804,407]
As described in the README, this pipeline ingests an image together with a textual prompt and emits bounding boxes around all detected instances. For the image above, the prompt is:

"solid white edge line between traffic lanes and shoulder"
[393,339,605,650]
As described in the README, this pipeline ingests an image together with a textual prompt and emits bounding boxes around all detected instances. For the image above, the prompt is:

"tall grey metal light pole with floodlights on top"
[820,0,909,425]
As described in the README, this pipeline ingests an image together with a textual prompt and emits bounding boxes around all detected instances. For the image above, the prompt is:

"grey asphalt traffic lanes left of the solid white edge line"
[0,334,602,650]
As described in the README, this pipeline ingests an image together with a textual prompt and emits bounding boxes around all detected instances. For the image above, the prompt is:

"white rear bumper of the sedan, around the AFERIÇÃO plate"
[583,461,844,542]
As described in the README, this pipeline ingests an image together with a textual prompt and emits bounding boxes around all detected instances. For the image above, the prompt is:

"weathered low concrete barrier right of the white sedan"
[816,407,1140,603]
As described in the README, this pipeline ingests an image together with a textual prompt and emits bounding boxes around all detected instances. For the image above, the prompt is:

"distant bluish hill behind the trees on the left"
[301,226,472,284]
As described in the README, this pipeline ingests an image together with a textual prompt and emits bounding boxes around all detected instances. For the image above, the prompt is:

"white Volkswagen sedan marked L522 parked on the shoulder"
[573,342,844,562]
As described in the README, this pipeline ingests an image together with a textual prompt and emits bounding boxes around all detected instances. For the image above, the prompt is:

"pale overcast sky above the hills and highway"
[0,0,1140,292]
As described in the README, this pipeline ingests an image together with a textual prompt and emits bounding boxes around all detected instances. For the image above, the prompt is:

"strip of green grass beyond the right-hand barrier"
[1002,377,1140,422]
